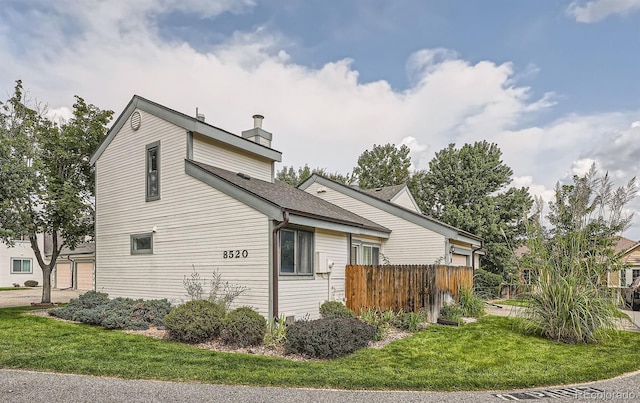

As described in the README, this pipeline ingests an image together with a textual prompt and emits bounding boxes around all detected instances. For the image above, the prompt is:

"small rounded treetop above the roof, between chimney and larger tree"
[353,144,411,189]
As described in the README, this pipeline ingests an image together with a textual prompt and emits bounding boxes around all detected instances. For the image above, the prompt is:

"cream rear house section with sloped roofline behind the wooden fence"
[298,174,482,268]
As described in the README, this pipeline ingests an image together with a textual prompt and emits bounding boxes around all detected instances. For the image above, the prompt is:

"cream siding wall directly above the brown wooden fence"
[305,183,445,264]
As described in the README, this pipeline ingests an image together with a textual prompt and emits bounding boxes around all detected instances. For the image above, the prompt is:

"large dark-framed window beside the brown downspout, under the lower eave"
[280,229,313,276]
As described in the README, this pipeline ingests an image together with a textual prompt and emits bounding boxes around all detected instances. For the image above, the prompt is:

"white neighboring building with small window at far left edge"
[0,235,44,287]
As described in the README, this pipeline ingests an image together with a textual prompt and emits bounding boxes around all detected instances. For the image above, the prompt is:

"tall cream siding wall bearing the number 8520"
[96,111,270,316]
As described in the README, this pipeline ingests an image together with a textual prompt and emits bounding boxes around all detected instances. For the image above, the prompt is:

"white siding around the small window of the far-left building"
[0,235,44,287]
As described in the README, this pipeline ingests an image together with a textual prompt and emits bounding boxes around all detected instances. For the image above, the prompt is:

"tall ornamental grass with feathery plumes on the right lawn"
[522,165,637,343]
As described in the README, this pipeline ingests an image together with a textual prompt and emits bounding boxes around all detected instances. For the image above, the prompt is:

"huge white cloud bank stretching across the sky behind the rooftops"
[0,0,640,238]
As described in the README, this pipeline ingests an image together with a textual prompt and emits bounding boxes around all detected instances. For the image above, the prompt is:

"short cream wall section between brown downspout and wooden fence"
[278,229,349,319]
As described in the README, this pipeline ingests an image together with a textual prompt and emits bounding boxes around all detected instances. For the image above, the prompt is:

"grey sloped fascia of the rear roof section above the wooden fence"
[298,173,482,246]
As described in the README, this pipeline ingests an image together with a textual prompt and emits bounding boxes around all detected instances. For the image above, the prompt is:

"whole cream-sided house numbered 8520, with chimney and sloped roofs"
[91,95,481,318]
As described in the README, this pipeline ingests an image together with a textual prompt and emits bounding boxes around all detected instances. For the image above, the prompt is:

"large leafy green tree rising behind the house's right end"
[409,141,533,279]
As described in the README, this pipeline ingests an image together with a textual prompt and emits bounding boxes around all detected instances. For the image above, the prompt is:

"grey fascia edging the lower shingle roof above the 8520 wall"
[185,160,391,239]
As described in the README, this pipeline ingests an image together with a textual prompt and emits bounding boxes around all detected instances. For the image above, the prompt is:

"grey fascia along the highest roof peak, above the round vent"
[91,95,282,165]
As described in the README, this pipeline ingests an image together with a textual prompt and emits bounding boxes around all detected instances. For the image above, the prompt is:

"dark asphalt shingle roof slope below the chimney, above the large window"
[189,161,391,233]
